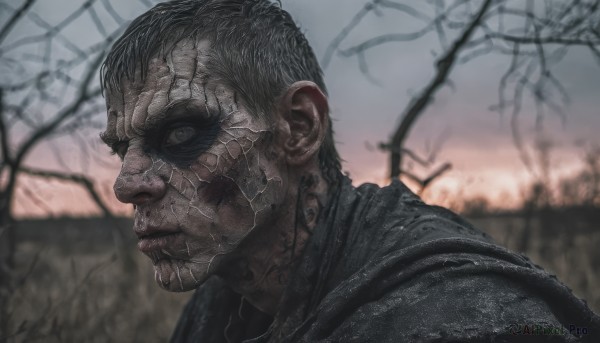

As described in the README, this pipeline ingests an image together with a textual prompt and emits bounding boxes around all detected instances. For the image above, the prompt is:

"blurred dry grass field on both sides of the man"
[2,213,600,342]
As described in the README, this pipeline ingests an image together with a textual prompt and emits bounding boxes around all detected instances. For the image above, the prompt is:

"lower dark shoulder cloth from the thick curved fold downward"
[307,240,600,342]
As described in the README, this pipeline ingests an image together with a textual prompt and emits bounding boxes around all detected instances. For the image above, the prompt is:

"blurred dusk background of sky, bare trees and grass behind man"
[0,0,600,342]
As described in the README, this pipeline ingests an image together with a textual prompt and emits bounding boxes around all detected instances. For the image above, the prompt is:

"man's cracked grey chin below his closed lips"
[154,259,209,292]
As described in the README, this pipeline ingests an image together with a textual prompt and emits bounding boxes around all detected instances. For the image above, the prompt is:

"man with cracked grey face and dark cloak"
[102,0,600,342]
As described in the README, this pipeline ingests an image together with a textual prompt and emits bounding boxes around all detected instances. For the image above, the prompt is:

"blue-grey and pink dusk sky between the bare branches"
[0,0,600,216]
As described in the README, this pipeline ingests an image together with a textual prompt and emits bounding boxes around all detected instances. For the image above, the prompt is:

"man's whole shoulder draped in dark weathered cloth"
[304,183,600,342]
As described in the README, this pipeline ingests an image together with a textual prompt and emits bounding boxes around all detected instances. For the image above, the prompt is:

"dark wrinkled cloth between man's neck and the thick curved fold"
[347,180,493,261]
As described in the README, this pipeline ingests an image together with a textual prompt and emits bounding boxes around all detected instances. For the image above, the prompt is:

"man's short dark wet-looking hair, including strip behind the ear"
[100,0,341,184]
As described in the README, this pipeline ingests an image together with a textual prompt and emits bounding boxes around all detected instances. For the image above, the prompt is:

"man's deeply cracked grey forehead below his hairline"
[103,39,237,140]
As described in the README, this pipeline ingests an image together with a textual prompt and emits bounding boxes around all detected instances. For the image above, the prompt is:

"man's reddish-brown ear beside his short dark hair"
[279,81,329,165]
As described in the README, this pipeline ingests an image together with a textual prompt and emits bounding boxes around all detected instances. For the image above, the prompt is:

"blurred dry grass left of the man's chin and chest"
[8,223,191,342]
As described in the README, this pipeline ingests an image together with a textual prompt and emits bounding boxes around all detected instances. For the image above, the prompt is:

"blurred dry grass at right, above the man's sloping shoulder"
[470,209,600,313]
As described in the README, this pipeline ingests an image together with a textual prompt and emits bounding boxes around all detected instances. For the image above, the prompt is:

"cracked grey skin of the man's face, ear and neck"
[102,39,329,314]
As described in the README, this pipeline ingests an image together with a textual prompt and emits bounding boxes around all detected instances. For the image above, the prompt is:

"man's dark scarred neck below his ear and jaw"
[221,168,328,315]
